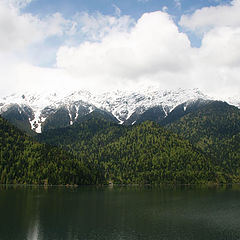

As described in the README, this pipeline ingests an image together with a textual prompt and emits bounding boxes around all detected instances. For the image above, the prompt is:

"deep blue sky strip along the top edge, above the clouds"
[22,0,231,49]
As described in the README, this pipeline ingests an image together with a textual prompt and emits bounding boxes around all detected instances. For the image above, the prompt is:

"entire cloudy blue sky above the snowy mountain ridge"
[0,0,240,97]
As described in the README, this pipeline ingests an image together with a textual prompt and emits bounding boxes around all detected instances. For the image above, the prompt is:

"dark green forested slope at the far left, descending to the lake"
[0,117,95,184]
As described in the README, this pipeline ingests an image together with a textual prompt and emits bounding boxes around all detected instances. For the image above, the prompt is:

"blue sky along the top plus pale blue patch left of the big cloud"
[21,0,231,66]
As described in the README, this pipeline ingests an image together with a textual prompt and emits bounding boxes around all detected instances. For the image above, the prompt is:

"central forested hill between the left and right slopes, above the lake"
[37,116,218,184]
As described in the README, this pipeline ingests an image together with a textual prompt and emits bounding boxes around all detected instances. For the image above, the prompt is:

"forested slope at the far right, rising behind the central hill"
[167,101,240,182]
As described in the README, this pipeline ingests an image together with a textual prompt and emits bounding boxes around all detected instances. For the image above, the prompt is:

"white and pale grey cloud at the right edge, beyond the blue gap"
[179,0,240,96]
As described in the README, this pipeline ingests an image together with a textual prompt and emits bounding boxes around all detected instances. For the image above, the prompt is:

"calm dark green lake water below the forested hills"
[0,185,240,240]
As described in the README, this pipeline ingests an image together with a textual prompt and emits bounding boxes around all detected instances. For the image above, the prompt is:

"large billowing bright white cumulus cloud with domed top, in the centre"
[57,12,191,89]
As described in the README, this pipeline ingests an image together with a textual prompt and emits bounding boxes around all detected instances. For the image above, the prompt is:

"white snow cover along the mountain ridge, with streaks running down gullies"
[0,87,213,132]
